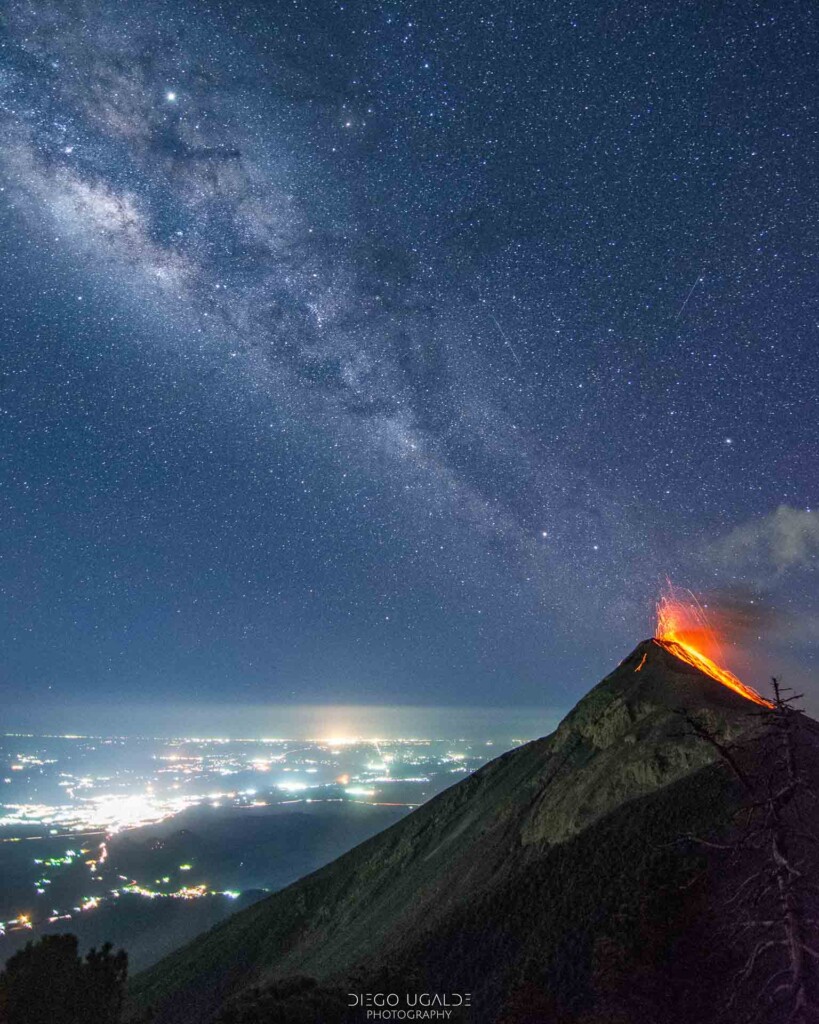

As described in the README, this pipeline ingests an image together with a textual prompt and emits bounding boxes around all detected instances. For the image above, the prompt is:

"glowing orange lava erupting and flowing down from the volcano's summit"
[654,585,773,708]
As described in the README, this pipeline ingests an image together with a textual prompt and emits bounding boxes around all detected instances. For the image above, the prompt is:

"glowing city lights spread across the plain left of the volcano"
[0,734,511,936]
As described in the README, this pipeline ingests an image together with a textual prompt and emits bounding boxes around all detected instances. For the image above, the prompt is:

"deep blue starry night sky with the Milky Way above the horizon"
[0,0,819,720]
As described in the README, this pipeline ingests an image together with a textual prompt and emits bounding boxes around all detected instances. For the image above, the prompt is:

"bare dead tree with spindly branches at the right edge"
[683,679,819,1024]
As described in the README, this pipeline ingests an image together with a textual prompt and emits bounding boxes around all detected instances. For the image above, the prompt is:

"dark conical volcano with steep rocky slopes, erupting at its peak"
[130,637,819,1024]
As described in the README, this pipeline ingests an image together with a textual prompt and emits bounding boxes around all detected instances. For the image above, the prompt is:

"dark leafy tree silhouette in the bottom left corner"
[0,935,128,1024]
